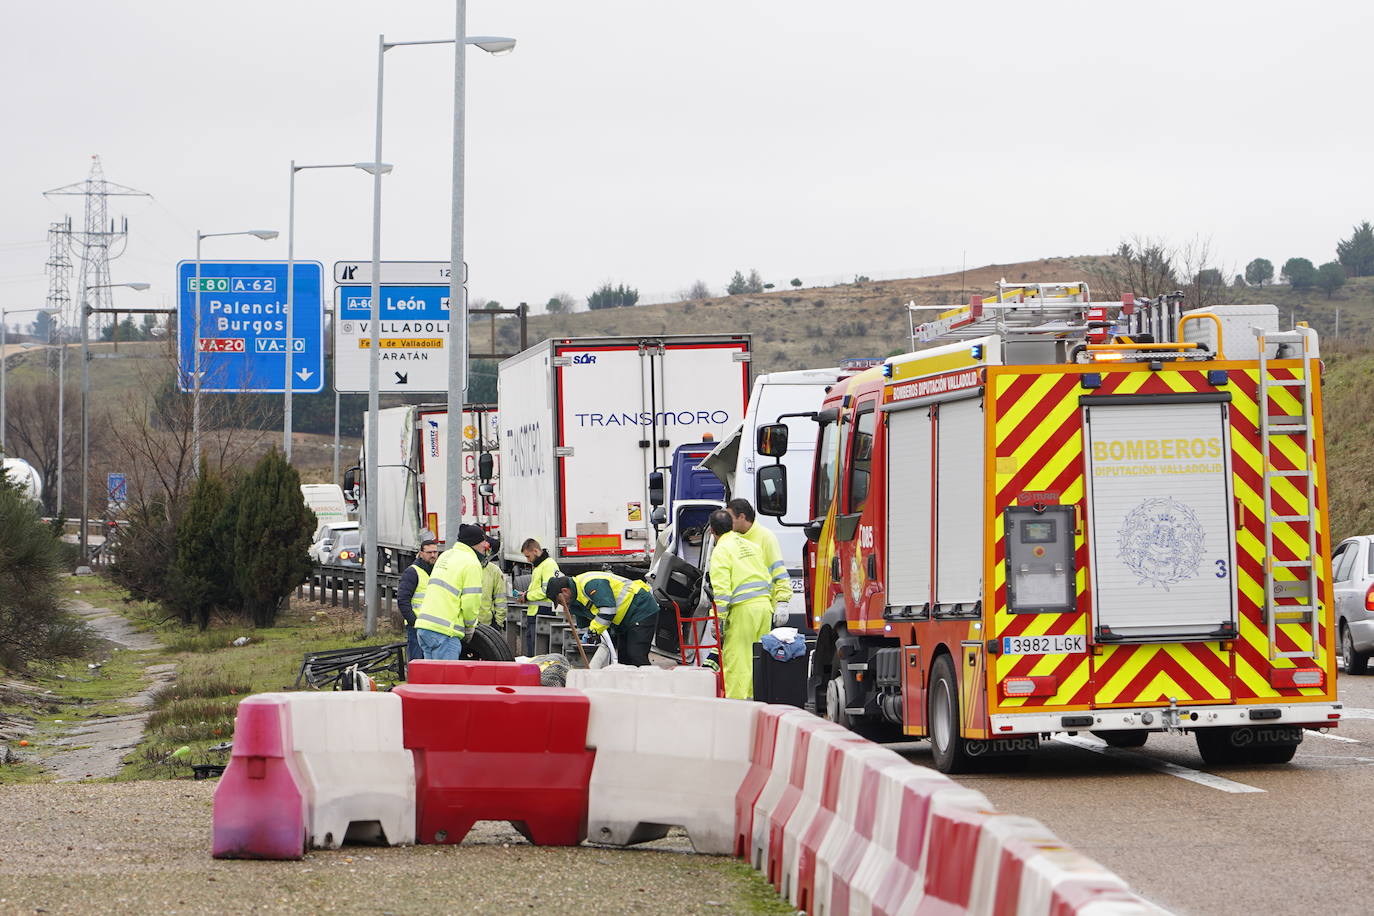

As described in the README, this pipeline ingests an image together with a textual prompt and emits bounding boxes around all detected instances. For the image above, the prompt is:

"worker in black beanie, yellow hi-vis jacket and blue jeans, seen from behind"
[415,525,486,661]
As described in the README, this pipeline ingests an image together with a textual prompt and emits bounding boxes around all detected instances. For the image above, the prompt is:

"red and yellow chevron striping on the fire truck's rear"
[984,361,1336,713]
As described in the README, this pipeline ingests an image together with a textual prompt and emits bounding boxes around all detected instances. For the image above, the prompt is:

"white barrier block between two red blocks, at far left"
[275,691,415,849]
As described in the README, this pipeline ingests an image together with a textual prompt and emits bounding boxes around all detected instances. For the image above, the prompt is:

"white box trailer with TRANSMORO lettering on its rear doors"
[496,335,750,570]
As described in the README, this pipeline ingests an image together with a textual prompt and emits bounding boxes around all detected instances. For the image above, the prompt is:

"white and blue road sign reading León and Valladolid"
[334,284,449,394]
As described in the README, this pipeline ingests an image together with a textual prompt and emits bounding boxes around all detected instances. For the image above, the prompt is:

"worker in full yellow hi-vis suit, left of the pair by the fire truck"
[710,509,774,699]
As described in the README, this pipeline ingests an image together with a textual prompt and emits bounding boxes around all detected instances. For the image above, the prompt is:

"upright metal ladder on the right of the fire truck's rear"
[1254,325,1322,658]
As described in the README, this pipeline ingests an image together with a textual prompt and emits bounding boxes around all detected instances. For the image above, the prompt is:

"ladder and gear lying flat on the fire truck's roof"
[907,280,1132,346]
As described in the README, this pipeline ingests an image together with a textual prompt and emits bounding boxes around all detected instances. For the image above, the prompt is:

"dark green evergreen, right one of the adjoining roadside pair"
[227,446,314,626]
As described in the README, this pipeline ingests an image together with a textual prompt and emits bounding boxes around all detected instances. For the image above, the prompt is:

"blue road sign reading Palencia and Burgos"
[177,261,324,394]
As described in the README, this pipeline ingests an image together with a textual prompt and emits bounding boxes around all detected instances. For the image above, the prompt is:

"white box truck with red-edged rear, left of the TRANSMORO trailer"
[345,405,500,555]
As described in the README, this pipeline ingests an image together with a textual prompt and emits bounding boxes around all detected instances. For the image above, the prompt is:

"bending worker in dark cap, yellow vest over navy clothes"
[545,571,658,666]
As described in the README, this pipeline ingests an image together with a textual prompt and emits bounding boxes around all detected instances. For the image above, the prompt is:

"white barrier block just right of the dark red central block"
[584,692,761,856]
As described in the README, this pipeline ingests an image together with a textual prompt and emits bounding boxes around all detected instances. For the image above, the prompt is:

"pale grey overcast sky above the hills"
[0,0,1374,321]
